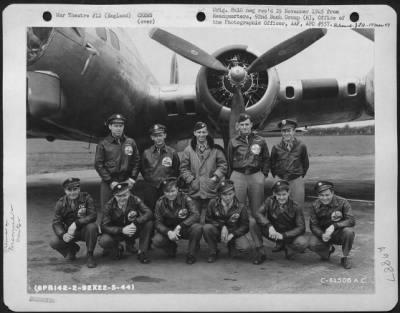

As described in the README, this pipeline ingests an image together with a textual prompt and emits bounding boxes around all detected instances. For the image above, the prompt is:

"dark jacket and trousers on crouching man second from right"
[250,196,308,255]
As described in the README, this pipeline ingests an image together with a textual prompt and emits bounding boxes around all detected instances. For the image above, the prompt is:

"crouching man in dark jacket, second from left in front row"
[99,183,153,264]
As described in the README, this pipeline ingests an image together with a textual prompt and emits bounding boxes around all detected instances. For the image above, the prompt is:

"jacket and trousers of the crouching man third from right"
[203,197,251,255]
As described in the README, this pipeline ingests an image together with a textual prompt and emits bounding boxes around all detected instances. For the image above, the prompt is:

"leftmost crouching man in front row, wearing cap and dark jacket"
[50,178,97,268]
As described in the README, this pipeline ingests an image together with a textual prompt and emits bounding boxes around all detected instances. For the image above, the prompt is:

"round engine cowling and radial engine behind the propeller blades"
[196,45,279,126]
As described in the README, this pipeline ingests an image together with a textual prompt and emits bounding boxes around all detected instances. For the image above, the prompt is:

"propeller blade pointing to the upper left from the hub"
[149,28,228,72]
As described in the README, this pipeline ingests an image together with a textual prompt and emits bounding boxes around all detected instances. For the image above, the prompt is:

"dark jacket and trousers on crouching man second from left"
[99,195,153,253]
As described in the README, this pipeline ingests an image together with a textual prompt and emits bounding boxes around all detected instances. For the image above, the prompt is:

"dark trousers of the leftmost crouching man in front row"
[50,223,98,257]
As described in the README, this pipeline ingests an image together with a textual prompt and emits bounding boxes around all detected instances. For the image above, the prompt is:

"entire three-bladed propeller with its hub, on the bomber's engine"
[150,28,327,138]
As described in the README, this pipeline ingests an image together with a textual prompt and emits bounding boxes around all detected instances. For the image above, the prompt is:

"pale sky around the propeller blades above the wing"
[128,28,374,124]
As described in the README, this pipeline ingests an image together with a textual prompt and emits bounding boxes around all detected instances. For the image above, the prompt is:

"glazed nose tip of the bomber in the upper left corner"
[27,27,53,65]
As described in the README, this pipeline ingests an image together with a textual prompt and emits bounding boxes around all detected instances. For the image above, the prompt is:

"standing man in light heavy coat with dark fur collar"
[180,122,228,224]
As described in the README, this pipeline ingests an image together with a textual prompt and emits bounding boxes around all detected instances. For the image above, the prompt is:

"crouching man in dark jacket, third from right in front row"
[203,180,251,263]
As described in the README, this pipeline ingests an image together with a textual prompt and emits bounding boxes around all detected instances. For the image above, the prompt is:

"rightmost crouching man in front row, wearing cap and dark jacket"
[309,181,355,269]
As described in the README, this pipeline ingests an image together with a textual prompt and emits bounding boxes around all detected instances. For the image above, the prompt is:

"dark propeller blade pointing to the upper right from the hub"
[247,28,326,74]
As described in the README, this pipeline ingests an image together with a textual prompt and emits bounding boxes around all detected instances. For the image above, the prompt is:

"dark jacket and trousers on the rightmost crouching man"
[309,195,355,259]
